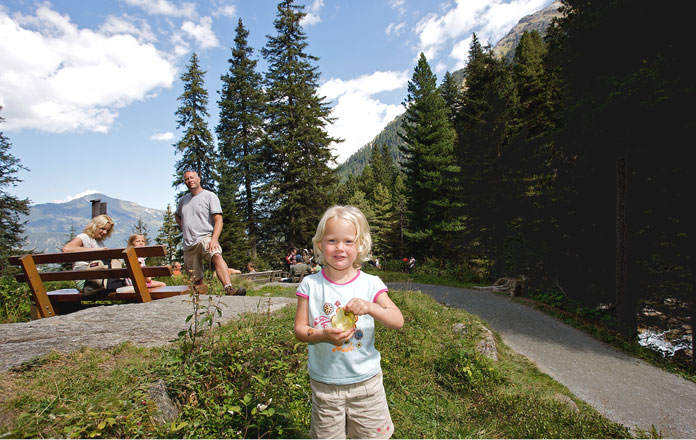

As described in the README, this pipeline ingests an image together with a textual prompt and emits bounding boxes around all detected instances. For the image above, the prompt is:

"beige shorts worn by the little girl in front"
[309,372,394,438]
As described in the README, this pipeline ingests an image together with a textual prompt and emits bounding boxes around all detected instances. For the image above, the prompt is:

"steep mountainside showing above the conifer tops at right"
[338,1,561,179]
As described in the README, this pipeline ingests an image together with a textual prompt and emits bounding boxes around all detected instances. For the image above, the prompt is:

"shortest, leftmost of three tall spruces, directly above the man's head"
[172,52,218,196]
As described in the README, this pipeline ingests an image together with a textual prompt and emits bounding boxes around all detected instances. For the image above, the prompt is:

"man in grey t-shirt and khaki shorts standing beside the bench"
[174,171,246,295]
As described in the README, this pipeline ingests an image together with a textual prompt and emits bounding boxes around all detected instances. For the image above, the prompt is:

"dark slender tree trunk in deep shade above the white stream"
[616,155,638,339]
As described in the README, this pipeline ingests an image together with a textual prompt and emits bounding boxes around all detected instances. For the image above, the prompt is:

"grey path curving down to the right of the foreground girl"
[388,283,696,438]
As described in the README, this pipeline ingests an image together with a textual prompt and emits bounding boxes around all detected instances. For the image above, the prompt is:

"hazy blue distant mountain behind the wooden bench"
[22,193,164,252]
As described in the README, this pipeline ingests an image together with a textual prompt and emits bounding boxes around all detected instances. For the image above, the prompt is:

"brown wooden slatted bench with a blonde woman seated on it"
[9,246,196,319]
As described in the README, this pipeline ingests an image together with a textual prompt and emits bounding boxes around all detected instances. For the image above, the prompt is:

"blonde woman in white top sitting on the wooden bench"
[63,214,125,295]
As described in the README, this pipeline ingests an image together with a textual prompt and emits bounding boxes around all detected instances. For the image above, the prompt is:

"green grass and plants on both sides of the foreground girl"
[0,286,630,438]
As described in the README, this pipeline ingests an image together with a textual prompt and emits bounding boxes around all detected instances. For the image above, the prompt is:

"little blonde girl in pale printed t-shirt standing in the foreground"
[295,206,404,438]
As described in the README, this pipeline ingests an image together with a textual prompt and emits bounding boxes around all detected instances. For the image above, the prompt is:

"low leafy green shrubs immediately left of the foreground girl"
[156,311,310,438]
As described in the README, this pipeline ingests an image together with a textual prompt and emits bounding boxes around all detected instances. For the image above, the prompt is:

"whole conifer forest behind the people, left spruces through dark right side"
[0,0,696,360]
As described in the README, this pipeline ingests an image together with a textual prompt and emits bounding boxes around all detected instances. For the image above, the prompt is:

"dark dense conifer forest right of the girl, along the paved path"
[336,0,696,358]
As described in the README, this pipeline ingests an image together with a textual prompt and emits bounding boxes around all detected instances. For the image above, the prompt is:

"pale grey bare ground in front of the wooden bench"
[0,295,296,371]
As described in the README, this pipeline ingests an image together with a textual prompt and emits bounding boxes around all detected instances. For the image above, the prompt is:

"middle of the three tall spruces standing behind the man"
[216,18,267,261]
